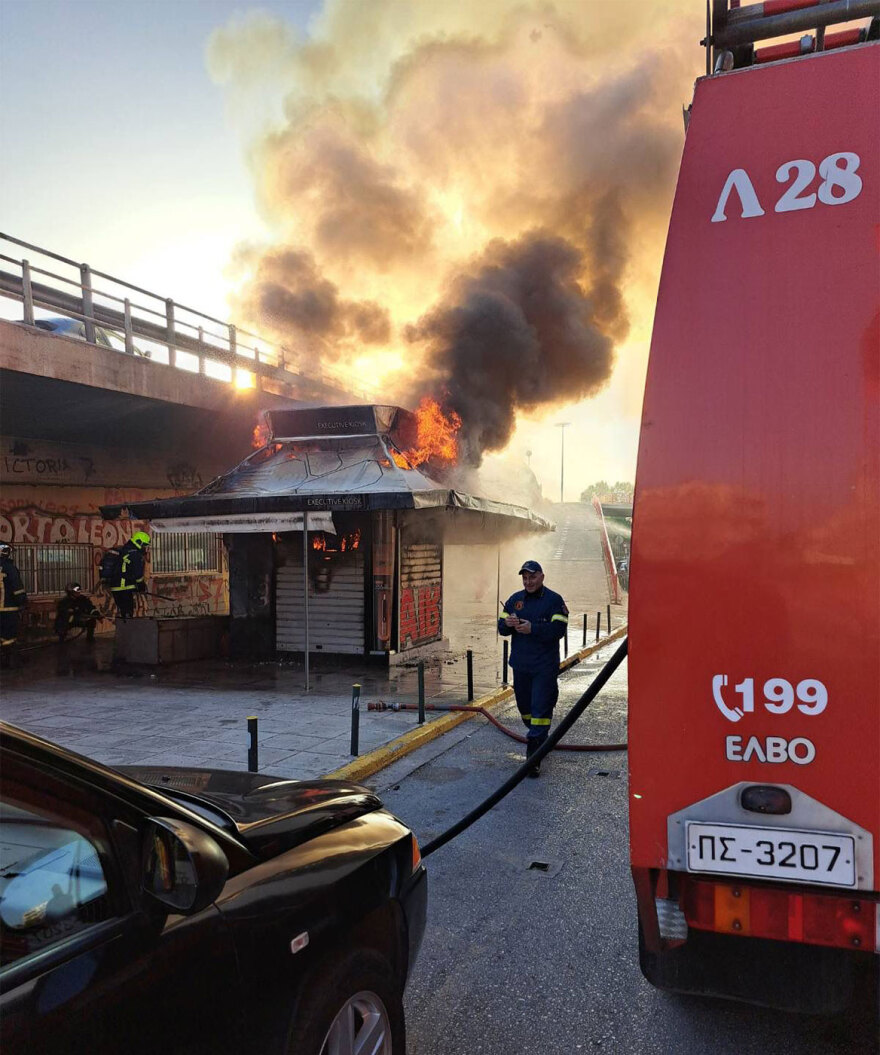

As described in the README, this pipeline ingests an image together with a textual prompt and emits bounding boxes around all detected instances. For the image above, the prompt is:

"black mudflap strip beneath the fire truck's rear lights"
[638,919,852,1015]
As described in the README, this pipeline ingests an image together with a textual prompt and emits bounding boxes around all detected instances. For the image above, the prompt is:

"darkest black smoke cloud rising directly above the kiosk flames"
[407,231,627,464]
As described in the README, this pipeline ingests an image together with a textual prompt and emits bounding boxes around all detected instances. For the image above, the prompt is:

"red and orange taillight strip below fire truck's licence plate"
[681,878,877,952]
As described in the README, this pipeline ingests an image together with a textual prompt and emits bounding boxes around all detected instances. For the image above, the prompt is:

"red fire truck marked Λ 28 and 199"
[629,0,880,1011]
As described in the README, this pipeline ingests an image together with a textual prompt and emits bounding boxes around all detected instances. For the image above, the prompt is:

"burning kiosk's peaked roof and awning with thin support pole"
[101,405,554,687]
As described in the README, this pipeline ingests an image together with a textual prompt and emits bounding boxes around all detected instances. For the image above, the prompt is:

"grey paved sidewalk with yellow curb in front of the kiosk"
[0,610,624,780]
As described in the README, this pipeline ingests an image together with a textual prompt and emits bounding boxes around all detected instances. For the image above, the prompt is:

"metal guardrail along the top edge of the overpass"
[0,233,381,403]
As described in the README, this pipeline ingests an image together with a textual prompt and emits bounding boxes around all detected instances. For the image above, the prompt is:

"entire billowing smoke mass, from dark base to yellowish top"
[209,0,702,465]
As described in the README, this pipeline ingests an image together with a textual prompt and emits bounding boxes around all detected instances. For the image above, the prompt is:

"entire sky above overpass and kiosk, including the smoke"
[0,0,704,500]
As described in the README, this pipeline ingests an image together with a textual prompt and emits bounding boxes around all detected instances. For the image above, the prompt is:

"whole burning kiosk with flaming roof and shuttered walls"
[101,406,553,657]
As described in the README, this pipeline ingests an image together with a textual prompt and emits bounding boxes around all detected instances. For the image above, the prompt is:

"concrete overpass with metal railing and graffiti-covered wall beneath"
[0,235,371,635]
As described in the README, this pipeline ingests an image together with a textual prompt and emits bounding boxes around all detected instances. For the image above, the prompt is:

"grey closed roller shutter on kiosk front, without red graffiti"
[275,551,365,655]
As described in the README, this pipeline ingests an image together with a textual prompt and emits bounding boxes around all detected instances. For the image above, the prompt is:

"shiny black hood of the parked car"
[116,766,382,857]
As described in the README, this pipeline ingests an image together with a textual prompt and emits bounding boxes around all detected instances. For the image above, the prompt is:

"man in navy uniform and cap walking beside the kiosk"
[498,560,569,776]
